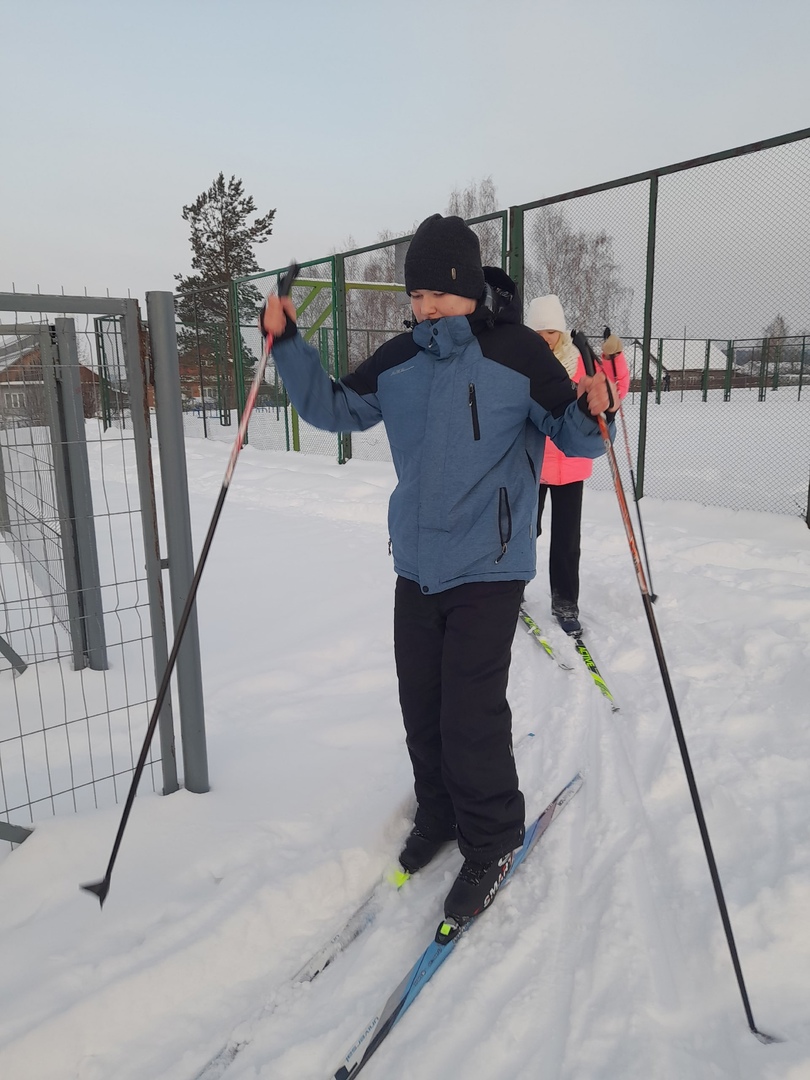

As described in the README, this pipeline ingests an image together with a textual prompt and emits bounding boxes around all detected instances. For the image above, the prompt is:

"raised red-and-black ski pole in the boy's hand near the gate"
[79,262,299,907]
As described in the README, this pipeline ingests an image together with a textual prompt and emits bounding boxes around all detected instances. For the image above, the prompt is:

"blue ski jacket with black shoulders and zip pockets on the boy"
[273,268,613,593]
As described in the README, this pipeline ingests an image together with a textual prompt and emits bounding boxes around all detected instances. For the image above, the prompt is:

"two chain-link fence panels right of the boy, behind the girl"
[515,131,810,514]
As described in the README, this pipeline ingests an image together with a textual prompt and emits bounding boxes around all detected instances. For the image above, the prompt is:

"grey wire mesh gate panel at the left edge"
[0,296,176,847]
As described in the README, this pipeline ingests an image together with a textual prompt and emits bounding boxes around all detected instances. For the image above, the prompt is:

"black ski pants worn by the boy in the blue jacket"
[394,578,525,862]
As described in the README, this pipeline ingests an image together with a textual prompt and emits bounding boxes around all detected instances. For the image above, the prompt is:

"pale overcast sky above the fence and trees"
[0,0,810,308]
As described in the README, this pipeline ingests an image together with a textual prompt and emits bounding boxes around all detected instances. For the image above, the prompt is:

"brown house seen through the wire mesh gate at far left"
[0,336,115,426]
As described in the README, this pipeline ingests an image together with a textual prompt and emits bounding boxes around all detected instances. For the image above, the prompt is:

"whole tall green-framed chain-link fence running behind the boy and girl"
[180,129,810,519]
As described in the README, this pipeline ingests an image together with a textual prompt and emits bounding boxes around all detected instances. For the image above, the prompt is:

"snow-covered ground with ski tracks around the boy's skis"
[0,432,810,1080]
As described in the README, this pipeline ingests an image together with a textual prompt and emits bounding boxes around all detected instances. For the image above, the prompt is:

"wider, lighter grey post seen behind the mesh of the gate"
[54,319,107,671]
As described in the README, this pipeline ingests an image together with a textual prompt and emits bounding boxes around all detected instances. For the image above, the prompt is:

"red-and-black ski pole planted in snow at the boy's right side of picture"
[572,333,781,1042]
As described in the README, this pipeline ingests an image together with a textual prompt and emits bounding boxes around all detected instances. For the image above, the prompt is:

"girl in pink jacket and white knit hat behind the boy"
[526,294,630,635]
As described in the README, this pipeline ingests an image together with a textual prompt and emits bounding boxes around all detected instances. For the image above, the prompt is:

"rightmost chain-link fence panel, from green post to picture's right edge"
[617,137,810,514]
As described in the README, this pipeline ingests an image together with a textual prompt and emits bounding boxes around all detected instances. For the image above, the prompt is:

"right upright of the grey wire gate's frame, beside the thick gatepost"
[121,300,179,795]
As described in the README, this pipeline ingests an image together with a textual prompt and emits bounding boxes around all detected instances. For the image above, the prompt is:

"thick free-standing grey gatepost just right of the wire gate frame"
[146,293,208,793]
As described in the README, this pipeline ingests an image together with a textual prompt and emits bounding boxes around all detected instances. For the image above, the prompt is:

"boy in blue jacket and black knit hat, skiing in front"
[261,214,618,923]
